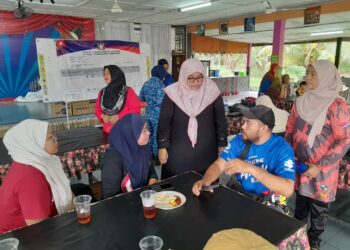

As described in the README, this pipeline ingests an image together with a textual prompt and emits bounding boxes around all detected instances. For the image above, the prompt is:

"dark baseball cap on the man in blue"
[242,105,275,129]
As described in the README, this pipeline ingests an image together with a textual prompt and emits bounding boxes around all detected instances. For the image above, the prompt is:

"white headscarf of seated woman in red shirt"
[4,119,72,214]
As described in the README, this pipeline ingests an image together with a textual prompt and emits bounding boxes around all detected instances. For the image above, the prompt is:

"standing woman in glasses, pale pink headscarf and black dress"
[157,59,227,179]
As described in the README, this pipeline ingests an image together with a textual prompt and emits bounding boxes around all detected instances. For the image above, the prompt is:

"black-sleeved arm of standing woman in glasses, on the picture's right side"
[214,96,227,148]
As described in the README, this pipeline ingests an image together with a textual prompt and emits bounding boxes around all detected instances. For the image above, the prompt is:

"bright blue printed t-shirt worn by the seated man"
[220,134,295,194]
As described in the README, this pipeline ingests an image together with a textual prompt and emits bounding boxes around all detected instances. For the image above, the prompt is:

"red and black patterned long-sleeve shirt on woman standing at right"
[285,98,350,202]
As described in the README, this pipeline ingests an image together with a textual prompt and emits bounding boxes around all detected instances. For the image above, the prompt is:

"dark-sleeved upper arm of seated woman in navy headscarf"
[101,150,124,199]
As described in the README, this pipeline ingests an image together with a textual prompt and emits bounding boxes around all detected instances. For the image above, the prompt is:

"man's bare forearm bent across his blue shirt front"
[225,159,294,197]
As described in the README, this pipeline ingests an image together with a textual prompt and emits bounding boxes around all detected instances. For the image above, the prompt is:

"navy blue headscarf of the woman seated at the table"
[109,114,151,189]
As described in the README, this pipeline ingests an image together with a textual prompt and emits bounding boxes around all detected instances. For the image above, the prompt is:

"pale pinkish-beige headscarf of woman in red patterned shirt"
[296,60,341,147]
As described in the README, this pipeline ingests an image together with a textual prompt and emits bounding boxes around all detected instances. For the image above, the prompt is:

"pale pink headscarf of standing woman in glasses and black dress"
[164,58,220,147]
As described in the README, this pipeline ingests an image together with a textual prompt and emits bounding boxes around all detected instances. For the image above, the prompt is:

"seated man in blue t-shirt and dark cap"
[192,105,295,197]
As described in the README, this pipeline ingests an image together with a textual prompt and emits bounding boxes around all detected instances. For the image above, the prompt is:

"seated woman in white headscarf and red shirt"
[0,119,72,233]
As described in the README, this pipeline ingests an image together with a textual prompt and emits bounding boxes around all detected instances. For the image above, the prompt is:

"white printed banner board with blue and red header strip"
[36,38,151,102]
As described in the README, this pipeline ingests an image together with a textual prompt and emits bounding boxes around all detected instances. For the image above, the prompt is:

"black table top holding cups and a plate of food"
[0,172,304,250]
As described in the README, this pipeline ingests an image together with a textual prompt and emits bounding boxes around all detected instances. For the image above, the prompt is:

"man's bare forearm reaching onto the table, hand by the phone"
[192,157,226,196]
